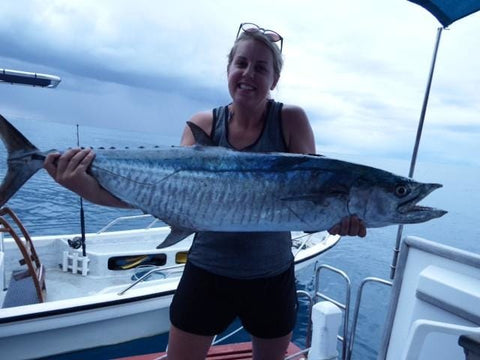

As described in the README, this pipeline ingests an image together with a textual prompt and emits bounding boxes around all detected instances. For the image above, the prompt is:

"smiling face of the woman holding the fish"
[228,40,278,106]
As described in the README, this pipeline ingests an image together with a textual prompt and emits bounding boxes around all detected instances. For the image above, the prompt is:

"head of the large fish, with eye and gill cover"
[349,173,447,227]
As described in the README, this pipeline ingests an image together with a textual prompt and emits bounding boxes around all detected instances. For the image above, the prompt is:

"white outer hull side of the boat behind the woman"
[0,295,173,359]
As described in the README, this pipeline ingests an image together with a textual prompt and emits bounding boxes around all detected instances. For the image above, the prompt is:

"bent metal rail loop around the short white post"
[313,264,352,359]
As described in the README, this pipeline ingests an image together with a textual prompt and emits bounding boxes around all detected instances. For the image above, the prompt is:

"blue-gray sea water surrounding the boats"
[0,119,480,360]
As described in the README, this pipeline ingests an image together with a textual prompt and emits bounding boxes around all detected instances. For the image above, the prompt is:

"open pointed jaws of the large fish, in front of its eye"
[397,184,447,223]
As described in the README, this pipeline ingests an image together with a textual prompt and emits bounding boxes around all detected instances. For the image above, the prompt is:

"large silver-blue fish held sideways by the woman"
[0,115,446,247]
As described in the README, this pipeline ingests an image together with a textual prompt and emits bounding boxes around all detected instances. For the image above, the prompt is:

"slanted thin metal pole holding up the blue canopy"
[390,27,443,279]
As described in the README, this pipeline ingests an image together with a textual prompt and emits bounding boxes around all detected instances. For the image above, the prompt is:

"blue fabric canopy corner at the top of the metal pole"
[408,0,480,27]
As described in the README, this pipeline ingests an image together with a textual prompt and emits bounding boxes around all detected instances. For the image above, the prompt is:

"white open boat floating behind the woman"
[0,208,339,359]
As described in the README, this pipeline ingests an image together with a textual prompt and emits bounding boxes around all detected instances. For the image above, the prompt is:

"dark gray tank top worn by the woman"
[188,100,293,279]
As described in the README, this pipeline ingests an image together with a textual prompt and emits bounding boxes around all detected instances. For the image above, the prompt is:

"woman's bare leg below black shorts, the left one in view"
[167,325,215,360]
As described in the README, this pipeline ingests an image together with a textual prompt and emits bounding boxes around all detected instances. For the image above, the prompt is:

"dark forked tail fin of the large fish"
[0,115,45,207]
